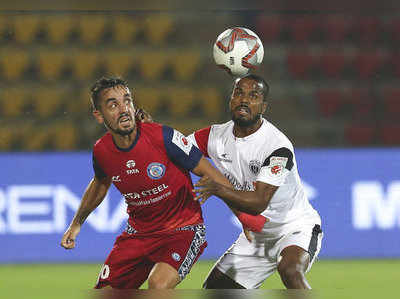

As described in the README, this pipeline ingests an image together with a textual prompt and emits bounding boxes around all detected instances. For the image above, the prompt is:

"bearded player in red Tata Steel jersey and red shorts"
[61,78,230,289]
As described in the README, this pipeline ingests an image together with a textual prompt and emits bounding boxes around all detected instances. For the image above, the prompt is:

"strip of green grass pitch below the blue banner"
[0,259,400,299]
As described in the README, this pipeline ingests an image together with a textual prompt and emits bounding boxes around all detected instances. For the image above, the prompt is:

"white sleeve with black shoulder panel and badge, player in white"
[257,147,293,186]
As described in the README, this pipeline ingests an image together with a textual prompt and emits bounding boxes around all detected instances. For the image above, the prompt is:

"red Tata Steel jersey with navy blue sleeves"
[93,123,203,234]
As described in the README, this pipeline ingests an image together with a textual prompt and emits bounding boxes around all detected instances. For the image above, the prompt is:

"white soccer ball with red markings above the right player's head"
[213,27,264,77]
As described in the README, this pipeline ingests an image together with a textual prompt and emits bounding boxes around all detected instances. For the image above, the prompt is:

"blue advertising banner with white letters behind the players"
[0,149,400,263]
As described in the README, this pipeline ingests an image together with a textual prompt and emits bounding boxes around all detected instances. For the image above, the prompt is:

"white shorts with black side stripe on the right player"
[214,224,323,289]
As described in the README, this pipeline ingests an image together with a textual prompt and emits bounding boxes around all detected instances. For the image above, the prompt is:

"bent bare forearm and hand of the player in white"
[195,177,278,215]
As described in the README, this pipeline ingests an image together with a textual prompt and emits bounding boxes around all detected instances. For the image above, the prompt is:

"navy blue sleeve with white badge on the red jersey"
[163,126,203,170]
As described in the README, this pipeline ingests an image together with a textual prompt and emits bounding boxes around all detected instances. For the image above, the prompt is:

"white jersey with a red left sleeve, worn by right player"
[189,118,321,233]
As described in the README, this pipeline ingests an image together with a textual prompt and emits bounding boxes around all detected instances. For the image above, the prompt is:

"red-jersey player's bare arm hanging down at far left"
[61,177,111,249]
